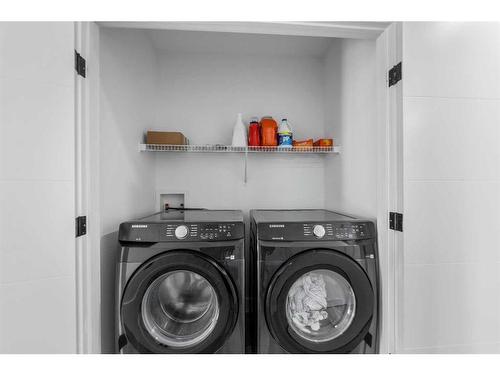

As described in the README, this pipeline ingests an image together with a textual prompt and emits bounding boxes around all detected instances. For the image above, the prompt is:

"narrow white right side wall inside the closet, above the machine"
[325,39,377,219]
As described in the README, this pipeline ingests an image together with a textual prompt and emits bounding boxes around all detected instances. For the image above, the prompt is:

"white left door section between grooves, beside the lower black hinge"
[0,181,75,284]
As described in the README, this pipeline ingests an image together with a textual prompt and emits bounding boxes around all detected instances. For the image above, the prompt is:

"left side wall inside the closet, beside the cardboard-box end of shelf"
[99,29,157,352]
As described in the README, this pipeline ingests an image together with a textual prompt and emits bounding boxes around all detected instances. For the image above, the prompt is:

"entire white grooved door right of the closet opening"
[399,23,500,353]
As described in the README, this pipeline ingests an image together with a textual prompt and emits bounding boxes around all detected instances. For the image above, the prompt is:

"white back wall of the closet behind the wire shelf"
[155,52,325,210]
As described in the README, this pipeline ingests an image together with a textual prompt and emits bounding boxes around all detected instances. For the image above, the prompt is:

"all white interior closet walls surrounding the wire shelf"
[97,29,377,220]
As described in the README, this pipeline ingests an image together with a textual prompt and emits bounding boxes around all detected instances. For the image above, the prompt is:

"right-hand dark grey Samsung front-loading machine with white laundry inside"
[248,210,379,353]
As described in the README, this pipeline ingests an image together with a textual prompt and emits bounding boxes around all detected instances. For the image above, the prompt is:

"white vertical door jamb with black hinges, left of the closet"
[74,22,101,354]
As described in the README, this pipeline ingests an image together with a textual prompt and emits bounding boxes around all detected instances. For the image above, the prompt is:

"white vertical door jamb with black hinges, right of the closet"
[377,22,403,353]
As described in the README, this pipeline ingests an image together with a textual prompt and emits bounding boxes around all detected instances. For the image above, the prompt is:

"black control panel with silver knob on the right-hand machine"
[258,221,376,241]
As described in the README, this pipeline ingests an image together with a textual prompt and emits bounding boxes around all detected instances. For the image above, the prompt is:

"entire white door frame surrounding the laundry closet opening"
[75,22,403,353]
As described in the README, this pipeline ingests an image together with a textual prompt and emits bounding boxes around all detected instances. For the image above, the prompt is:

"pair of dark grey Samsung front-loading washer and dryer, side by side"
[116,210,378,353]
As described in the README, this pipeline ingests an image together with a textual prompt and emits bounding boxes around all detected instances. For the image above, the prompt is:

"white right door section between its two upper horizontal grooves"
[404,97,500,180]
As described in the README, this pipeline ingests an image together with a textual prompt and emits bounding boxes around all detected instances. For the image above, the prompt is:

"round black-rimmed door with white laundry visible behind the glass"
[266,249,374,353]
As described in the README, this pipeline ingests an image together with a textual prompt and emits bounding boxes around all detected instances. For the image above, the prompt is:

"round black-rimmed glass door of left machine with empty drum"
[121,250,239,353]
